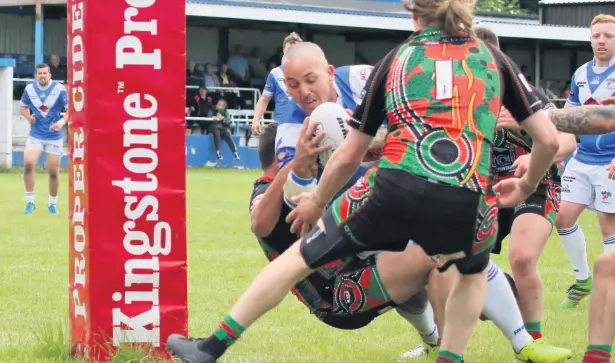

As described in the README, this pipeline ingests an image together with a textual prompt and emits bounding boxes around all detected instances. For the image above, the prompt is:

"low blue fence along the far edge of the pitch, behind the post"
[13,135,260,169]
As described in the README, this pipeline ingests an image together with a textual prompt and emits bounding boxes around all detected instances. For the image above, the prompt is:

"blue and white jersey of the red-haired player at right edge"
[566,58,615,165]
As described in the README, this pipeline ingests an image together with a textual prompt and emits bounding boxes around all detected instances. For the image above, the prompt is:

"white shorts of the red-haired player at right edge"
[562,158,615,213]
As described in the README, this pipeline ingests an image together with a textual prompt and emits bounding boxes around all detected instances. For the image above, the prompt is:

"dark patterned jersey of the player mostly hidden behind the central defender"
[491,87,560,194]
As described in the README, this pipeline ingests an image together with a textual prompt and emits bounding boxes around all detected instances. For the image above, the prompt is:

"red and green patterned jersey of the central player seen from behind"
[349,28,542,194]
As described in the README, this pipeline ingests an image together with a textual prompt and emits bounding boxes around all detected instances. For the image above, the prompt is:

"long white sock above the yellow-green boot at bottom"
[483,261,532,353]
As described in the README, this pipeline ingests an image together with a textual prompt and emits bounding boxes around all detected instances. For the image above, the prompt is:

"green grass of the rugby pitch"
[0,169,602,363]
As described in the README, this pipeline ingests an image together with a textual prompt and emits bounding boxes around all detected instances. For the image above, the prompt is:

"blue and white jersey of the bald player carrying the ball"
[276,65,374,167]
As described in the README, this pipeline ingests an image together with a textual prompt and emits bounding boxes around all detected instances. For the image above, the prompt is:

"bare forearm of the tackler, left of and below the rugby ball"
[250,167,290,237]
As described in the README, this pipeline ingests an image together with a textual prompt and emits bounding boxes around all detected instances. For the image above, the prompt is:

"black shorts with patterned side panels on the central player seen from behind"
[301,169,497,274]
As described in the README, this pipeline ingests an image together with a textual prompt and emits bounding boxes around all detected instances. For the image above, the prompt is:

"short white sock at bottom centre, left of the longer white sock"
[395,290,440,345]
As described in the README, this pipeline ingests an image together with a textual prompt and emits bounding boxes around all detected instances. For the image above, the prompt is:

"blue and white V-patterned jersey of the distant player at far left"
[20,81,68,140]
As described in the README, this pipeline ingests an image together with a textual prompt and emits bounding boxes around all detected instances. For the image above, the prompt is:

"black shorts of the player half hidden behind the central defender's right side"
[491,183,560,255]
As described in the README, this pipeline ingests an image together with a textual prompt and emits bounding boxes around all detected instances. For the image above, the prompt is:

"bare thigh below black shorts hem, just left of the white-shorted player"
[509,194,557,268]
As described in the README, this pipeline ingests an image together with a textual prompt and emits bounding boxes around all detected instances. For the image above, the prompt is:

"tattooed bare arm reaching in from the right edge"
[548,106,615,135]
